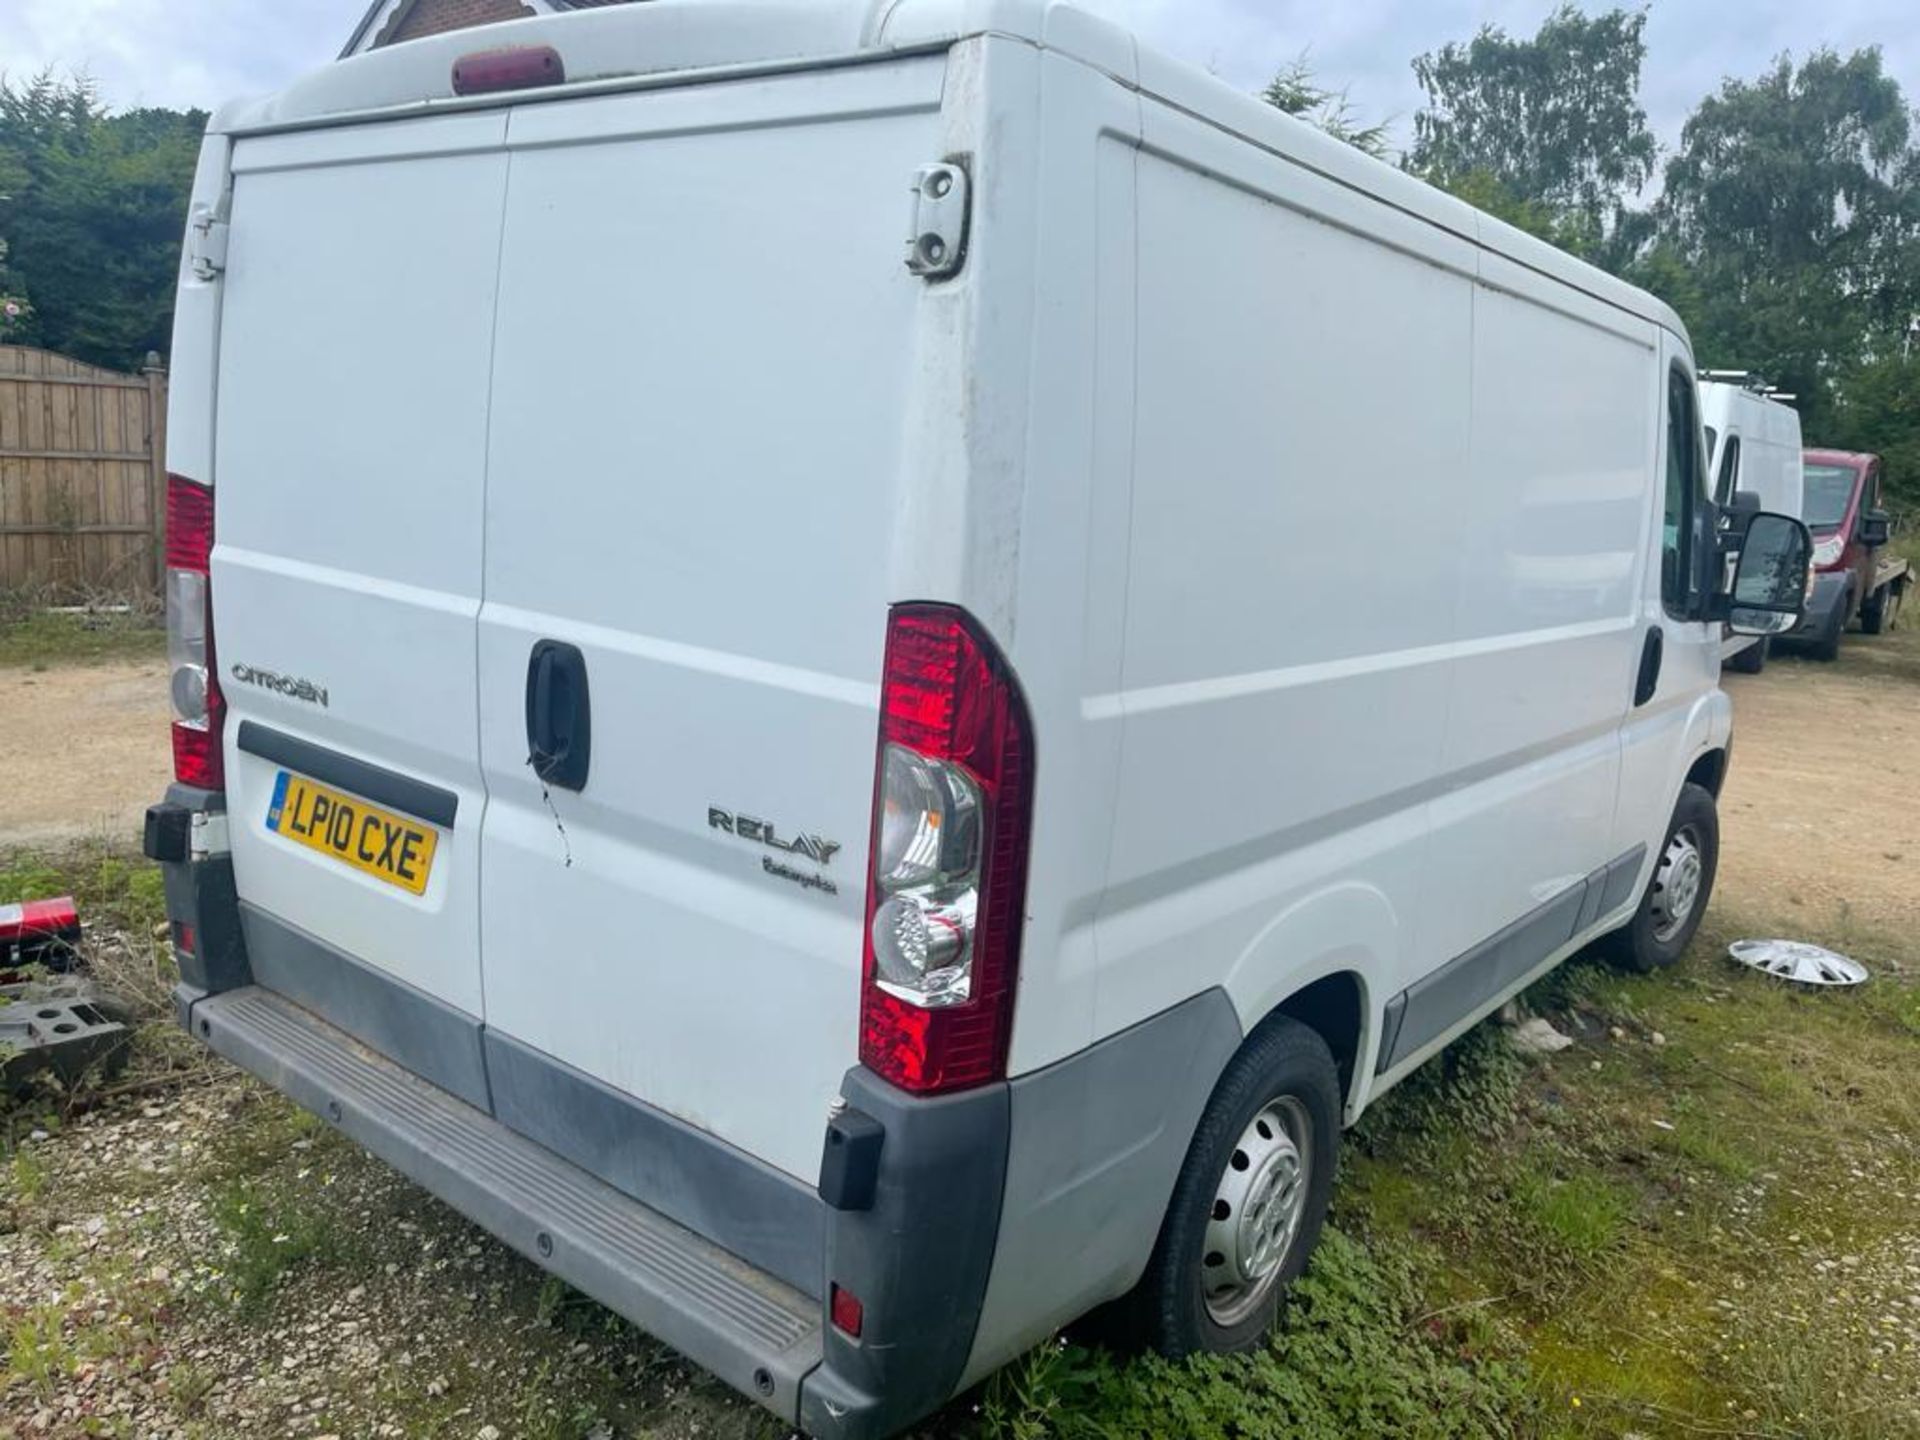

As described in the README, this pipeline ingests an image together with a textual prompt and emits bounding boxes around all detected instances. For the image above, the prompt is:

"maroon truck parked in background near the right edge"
[1782,449,1912,660]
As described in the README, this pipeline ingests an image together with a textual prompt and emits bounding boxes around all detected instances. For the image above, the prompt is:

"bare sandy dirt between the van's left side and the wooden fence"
[0,660,173,849]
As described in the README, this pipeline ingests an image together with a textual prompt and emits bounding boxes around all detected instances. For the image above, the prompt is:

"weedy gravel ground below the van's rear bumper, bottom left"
[0,1062,781,1440]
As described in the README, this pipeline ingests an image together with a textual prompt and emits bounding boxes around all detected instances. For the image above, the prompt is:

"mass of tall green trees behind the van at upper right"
[1405,18,1920,507]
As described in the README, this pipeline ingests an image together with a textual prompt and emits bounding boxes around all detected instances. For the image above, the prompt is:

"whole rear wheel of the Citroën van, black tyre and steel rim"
[1114,1016,1340,1359]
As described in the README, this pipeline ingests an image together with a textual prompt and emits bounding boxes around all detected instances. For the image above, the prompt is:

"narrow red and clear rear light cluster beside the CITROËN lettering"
[167,474,227,789]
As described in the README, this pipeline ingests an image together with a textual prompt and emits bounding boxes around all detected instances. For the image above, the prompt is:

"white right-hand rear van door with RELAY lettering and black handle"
[480,58,958,1183]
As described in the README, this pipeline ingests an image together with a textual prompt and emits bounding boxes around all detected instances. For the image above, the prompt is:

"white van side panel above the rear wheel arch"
[1096,115,1475,1035]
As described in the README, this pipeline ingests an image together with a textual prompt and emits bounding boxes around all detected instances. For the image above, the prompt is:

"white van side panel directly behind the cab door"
[1427,268,1657,971]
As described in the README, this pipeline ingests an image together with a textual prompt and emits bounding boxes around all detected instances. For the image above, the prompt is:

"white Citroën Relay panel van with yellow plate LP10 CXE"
[148,0,1807,1436]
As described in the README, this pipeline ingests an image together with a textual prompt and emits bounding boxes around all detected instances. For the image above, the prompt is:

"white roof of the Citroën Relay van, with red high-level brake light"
[211,0,1686,338]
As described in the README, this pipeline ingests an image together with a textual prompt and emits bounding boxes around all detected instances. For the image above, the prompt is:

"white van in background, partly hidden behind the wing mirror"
[1699,380,1805,674]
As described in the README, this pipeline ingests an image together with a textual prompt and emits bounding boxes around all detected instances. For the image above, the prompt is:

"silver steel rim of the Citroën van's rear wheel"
[1200,1094,1313,1327]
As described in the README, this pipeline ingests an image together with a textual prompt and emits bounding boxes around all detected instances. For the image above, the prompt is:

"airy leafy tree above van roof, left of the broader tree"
[1405,4,1657,244]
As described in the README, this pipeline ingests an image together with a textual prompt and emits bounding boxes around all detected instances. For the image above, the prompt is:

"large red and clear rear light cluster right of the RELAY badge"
[860,605,1033,1094]
